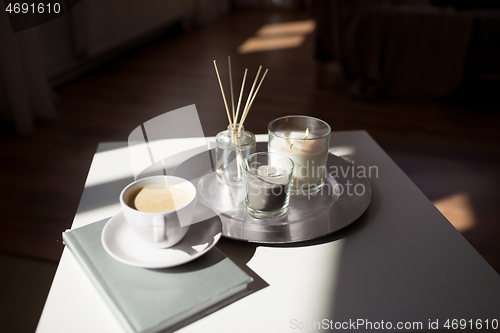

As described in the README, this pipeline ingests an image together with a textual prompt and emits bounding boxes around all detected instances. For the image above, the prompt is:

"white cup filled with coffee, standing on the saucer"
[120,176,196,248]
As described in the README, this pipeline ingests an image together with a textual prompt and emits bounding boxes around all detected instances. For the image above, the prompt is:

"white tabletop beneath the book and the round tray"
[37,131,500,333]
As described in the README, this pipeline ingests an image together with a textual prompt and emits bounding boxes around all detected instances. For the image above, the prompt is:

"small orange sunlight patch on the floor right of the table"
[433,193,477,232]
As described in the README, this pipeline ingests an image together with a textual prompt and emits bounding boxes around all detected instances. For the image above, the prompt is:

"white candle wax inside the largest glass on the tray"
[269,131,328,190]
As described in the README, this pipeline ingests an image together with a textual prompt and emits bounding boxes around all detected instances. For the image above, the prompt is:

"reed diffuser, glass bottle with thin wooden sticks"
[214,57,268,186]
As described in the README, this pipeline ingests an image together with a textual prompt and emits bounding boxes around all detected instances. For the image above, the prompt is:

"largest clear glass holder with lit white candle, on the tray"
[268,116,331,195]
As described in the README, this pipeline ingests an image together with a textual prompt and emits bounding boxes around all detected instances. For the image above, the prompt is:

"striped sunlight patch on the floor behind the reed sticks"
[238,20,316,54]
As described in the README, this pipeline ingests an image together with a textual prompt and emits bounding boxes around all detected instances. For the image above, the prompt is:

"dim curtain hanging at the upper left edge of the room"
[0,11,56,134]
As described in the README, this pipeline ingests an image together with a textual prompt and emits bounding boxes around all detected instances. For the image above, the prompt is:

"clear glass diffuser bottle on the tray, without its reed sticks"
[215,124,256,186]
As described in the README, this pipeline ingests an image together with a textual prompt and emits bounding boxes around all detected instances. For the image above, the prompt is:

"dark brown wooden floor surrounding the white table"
[0,11,500,272]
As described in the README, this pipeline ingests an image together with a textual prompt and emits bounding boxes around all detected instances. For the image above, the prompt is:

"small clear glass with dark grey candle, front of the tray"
[242,152,293,218]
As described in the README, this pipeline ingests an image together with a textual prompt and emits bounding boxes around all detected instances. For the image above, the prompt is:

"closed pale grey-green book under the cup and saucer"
[63,219,252,333]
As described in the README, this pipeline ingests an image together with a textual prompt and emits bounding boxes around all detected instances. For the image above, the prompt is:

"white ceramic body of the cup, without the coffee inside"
[120,176,196,248]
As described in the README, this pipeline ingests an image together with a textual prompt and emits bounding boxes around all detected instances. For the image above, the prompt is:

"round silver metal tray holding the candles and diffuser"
[172,143,371,244]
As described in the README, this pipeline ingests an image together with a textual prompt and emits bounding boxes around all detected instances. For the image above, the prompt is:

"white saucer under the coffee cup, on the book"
[101,205,222,268]
